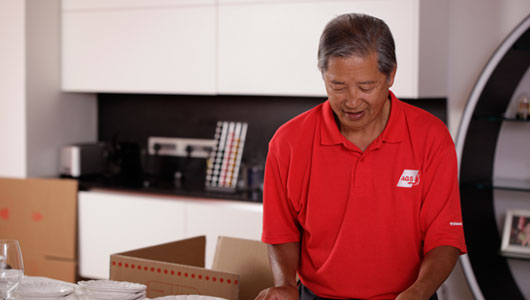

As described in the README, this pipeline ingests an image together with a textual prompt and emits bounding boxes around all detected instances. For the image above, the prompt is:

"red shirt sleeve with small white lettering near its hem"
[420,138,467,254]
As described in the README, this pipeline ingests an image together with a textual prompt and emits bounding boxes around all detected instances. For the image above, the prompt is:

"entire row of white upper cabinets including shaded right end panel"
[63,0,448,98]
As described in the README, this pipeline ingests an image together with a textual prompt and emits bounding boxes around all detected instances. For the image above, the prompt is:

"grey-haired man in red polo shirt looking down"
[256,14,466,300]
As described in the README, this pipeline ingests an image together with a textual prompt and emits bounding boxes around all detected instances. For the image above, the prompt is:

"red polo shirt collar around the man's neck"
[320,91,405,148]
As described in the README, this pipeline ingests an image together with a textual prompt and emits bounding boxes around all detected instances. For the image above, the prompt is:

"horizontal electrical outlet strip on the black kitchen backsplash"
[148,136,215,158]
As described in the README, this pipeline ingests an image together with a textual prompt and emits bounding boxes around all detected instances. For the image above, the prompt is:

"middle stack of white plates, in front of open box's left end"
[77,280,146,300]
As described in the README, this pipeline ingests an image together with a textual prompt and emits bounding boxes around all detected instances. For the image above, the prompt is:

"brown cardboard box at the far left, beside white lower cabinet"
[0,178,77,282]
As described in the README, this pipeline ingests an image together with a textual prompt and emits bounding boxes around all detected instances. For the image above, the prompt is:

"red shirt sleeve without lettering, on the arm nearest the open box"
[262,141,300,244]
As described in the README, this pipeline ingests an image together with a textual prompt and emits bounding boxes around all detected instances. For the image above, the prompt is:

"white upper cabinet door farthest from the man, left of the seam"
[62,0,216,94]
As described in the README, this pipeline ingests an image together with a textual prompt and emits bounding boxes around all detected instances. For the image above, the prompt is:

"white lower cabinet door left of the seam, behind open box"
[79,192,184,278]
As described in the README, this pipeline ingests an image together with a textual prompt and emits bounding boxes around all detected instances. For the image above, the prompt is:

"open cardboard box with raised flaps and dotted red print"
[110,236,273,300]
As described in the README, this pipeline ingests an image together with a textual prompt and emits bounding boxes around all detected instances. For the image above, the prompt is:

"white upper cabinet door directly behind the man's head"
[218,0,418,96]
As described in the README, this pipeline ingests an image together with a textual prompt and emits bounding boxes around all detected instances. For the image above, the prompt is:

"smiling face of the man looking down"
[323,53,395,134]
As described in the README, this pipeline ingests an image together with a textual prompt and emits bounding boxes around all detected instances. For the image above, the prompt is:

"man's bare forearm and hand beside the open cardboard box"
[255,242,300,300]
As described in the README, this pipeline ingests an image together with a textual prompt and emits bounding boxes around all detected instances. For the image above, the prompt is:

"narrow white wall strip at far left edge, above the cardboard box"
[0,0,26,177]
